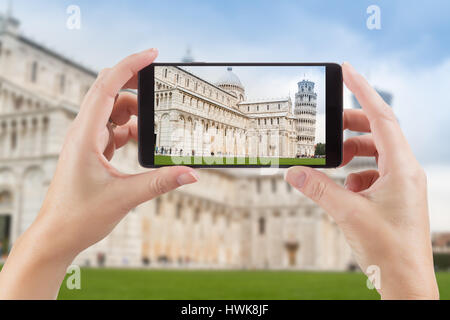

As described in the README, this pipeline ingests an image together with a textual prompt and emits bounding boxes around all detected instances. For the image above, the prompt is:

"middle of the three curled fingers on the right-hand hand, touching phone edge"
[341,134,378,167]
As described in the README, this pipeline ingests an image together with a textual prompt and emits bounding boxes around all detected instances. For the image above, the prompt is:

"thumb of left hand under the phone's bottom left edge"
[115,166,198,209]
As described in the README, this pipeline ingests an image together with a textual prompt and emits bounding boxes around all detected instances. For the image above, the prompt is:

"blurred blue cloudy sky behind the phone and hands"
[0,0,450,229]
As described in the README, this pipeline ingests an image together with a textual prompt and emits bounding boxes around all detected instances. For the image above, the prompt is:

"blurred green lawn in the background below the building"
[59,269,450,299]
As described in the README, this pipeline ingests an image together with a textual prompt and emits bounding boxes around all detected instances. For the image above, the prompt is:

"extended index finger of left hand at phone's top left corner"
[80,49,157,134]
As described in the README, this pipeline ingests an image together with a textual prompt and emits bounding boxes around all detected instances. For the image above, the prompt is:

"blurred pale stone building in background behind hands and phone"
[0,11,358,270]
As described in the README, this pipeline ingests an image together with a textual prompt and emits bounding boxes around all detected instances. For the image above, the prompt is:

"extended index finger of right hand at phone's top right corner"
[342,62,414,171]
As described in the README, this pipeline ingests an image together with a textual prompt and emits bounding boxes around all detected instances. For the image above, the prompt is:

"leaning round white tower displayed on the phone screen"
[294,80,317,157]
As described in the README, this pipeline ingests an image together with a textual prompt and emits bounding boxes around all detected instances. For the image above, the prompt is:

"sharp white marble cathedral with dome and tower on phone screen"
[154,66,317,158]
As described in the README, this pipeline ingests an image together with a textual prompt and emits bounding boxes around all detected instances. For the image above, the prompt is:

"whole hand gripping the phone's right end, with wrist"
[286,63,439,299]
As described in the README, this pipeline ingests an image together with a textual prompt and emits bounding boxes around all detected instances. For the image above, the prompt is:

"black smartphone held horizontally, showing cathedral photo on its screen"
[138,62,343,168]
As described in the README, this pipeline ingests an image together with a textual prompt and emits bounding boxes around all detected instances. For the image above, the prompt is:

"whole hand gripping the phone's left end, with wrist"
[0,49,197,299]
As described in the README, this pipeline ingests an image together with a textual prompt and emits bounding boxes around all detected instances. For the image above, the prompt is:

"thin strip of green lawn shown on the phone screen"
[155,155,326,166]
